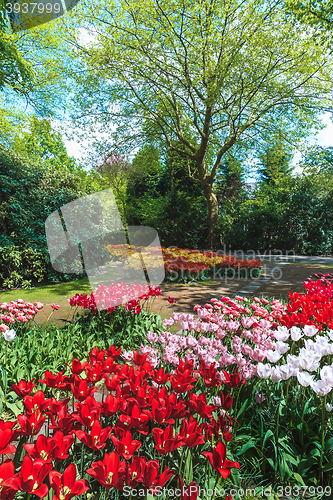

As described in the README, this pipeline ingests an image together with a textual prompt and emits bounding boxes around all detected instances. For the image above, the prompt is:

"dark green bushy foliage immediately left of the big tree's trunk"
[127,144,208,249]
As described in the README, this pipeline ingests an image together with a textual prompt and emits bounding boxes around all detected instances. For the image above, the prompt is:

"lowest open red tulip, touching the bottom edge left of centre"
[49,464,89,500]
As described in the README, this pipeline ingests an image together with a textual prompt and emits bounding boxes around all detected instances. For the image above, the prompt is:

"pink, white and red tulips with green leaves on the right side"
[136,288,333,491]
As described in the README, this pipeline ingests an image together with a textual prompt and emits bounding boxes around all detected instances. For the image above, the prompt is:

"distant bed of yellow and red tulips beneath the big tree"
[107,245,262,282]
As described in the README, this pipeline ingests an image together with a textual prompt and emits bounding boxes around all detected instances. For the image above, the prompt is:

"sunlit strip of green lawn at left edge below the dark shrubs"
[0,278,91,304]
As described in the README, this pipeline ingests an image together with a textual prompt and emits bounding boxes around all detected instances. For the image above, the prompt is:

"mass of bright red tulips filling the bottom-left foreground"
[0,346,244,500]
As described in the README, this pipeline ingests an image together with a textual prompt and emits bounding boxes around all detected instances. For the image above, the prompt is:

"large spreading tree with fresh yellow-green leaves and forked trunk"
[64,0,332,248]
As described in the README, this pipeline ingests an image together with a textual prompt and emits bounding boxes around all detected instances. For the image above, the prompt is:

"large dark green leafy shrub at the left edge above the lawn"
[0,148,85,248]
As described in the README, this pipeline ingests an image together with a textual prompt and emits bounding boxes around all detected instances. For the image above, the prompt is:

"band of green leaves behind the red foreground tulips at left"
[0,308,163,390]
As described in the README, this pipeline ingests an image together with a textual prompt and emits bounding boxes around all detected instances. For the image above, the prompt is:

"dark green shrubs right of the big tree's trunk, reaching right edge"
[220,172,333,255]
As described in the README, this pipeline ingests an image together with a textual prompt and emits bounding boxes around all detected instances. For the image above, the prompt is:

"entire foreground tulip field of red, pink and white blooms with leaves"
[0,275,333,500]
